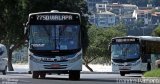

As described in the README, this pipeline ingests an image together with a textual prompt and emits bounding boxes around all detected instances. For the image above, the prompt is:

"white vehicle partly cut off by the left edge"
[0,44,8,75]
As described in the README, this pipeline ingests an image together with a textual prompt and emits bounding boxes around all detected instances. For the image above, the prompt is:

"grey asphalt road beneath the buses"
[0,73,154,84]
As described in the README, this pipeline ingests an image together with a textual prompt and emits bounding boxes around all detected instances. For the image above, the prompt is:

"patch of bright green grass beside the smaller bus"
[144,69,160,77]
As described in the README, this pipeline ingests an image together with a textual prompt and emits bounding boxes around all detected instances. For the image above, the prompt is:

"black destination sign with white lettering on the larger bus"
[28,13,80,25]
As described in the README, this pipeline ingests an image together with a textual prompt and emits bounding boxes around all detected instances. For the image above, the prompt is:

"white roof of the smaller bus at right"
[112,36,160,41]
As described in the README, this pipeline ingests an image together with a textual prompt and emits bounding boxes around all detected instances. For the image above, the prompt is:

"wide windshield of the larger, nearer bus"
[29,25,80,50]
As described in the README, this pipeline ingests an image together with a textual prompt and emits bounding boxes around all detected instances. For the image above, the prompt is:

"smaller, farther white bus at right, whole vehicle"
[110,36,160,76]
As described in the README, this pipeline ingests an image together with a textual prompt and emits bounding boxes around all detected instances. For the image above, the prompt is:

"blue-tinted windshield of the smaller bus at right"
[111,44,140,59]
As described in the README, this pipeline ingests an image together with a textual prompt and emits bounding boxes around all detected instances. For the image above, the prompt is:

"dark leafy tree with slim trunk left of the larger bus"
[0,0,25,71]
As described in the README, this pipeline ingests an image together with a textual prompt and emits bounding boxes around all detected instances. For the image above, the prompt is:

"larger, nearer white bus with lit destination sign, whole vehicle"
[25,11,82,80]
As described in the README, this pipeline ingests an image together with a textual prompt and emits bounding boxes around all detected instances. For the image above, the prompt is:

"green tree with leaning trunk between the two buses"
[83,24,126,72]
